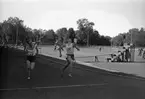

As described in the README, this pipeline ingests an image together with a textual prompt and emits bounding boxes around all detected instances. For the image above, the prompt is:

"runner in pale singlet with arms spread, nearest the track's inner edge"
[61,39,80,77]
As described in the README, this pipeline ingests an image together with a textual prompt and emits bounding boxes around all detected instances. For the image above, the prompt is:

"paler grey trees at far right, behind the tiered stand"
[111,27,145,47]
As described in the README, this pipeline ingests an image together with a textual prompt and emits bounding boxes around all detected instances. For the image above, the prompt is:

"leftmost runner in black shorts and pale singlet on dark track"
[26,40,38,79]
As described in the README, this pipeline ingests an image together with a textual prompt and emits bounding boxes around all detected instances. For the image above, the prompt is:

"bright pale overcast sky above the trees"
[0,0,145,37]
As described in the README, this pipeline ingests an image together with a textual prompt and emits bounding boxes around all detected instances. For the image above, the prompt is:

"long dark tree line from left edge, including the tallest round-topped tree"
[0,17,111,46]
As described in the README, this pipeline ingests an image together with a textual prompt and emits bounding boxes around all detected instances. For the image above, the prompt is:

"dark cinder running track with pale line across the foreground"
[0,48,145,99]
